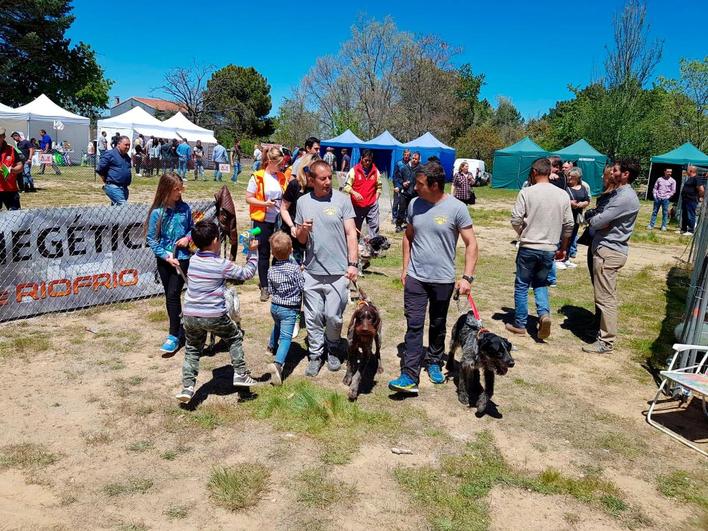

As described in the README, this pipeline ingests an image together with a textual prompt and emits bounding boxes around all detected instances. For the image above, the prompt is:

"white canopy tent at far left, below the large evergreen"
[0,94,90,160]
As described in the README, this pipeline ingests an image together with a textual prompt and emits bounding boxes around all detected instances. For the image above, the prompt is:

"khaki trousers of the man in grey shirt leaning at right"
[592,247,627,346]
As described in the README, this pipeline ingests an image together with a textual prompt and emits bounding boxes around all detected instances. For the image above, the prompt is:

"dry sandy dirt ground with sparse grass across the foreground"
[0,189,708,530]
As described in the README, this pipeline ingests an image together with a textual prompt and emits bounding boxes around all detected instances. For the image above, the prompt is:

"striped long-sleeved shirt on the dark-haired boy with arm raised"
[182,251,258,317]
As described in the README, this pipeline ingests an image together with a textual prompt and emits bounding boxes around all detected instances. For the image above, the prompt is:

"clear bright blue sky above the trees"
[68,0,708,117]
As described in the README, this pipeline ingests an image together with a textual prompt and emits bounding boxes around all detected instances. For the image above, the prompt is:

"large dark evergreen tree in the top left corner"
[0,0,113,118]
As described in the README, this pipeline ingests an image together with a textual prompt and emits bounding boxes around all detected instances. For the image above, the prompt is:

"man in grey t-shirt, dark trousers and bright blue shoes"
[388,162,479,394]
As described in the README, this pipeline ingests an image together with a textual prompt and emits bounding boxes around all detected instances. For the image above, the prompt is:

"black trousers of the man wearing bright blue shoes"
[402,276,455,382]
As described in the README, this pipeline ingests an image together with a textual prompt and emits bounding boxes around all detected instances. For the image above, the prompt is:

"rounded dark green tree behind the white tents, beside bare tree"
[204,65,274,138]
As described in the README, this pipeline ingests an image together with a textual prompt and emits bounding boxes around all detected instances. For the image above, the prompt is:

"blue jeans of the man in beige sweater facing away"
[514,247,555,328]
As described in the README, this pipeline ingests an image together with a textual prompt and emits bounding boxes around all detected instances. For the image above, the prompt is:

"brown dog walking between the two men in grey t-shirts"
[343,289,383,400]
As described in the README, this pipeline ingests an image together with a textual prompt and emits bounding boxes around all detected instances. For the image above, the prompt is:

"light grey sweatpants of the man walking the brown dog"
[303,271,349,359]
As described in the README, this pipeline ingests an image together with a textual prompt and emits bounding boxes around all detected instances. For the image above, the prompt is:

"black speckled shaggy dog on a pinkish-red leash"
[447,311,514,416]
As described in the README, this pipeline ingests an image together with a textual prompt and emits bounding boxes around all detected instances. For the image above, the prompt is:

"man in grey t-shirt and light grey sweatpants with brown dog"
[295,160,359,376]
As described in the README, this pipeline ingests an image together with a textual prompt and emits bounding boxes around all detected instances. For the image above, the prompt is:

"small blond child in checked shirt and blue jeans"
[268,231,305,385]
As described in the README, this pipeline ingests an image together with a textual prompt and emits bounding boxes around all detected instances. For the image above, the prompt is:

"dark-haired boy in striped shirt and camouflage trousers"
[176,221,258,403]
